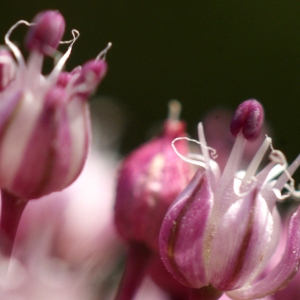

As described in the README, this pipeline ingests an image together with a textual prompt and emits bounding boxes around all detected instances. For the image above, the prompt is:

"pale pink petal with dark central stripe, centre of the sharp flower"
[209,191,273,290]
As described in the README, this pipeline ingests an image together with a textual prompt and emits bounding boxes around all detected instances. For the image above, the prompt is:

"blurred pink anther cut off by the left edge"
[0,49,16,92]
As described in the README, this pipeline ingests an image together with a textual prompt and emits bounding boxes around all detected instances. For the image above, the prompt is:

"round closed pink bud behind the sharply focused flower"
[115,102,192,250]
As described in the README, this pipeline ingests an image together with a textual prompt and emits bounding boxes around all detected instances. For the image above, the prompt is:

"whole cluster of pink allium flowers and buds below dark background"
[0,11,300,300]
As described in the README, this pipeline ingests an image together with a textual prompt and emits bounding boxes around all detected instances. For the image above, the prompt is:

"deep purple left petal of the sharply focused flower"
[159,170,213,288]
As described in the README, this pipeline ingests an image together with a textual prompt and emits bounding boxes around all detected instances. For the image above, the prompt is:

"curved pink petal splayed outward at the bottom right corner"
[227,208,300,300]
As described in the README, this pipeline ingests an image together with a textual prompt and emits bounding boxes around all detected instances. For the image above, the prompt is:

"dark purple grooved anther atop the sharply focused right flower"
[230,99,264,140]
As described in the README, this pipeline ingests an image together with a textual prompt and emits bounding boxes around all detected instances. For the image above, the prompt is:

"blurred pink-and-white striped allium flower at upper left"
[0,11,107,199]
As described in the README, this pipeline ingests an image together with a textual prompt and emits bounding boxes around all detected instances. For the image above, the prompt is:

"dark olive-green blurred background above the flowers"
[0,0,300,166]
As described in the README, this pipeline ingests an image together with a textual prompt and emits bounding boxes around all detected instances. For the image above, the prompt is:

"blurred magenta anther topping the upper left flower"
[25,10,65,55]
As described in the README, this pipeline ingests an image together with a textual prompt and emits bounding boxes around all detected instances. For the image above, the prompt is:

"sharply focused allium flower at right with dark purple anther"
[160,100,300,299]
